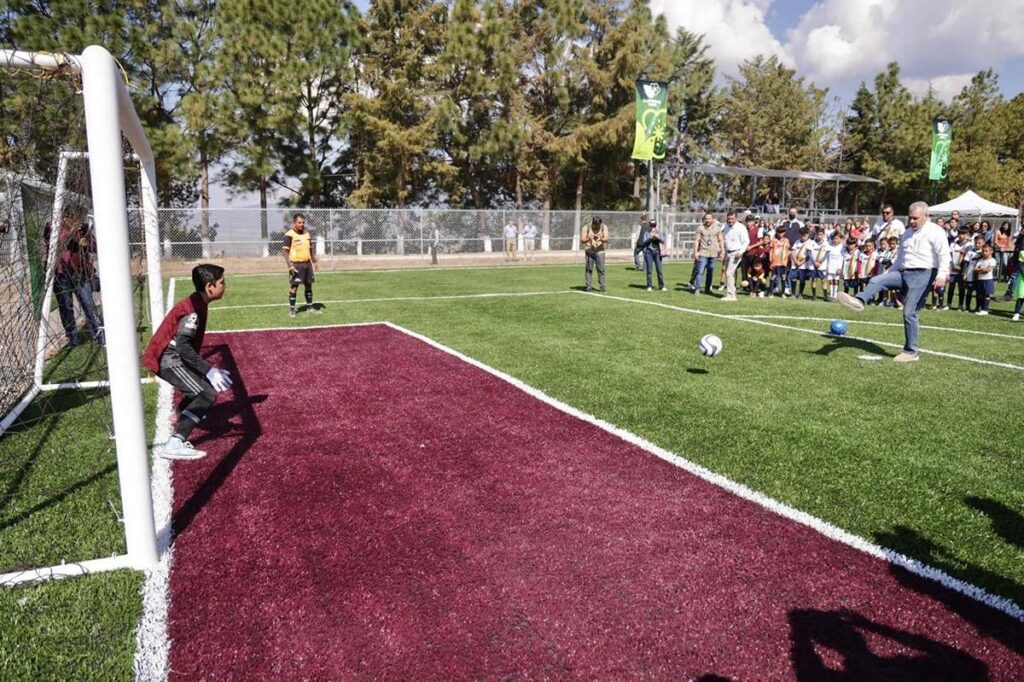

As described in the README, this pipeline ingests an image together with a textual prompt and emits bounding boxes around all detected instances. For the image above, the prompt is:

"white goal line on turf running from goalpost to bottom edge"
[132,278,175,682]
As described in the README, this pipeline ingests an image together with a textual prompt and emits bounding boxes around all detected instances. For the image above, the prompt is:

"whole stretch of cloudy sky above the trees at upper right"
[650,0,1024,99]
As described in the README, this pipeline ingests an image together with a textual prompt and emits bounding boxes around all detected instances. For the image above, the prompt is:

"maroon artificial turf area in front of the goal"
[170,326,1024,680]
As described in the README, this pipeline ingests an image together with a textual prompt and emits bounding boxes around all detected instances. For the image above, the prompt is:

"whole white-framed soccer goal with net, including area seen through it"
[0,47,163,585]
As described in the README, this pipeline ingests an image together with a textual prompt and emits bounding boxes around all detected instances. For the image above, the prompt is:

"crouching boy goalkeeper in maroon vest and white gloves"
[142,263,231,460]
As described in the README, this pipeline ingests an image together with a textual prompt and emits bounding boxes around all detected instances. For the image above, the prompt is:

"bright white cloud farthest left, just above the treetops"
[650,0,794,76]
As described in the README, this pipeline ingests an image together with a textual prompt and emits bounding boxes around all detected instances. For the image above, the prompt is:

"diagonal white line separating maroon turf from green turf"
[383,319,1024,622]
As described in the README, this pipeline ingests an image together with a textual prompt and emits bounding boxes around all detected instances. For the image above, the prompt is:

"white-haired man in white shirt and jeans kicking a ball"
[839,202,949,363]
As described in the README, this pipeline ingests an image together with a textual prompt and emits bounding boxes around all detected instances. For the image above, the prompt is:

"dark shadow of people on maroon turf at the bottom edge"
[788,609,988,680]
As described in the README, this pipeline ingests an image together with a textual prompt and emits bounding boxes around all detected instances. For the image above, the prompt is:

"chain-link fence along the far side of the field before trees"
[132,202,1015,261]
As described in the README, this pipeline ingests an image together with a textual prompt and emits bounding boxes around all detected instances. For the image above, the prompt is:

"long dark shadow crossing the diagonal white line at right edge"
[874,525,1024,655]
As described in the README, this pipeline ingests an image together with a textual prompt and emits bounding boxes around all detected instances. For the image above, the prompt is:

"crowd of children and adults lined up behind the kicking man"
[689,205,1024,322]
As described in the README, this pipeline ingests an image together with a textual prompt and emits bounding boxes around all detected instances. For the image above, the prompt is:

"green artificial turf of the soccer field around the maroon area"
[0,263,1024,679]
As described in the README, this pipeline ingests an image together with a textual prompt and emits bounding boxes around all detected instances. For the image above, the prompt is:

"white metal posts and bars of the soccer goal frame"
[0,45,165,585]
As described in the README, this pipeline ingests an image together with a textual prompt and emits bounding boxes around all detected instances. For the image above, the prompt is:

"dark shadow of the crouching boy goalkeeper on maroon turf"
[172,345,266,537]
